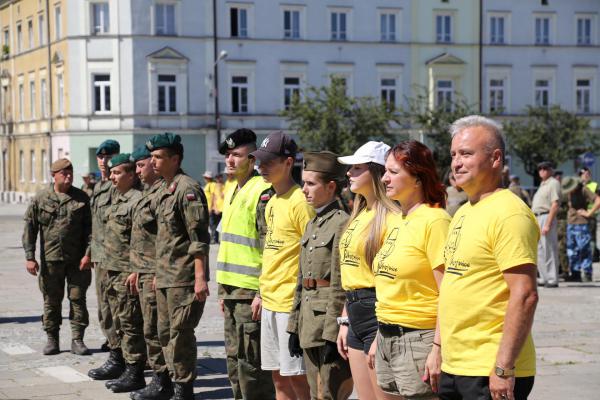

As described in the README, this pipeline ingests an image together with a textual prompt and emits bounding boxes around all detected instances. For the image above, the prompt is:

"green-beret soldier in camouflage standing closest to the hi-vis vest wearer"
[146,133,210,400]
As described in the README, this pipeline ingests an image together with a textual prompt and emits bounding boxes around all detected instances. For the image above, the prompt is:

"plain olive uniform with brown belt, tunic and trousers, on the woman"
[288,201,353,400]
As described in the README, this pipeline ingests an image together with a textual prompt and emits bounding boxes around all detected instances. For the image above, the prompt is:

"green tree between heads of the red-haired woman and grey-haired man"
[401,87,475,179]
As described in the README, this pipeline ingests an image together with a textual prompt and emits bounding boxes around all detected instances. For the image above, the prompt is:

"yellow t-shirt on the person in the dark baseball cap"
[259,185,315,312]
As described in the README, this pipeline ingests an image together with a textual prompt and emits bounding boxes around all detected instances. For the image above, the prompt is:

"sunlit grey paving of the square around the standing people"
[0,204,600,400]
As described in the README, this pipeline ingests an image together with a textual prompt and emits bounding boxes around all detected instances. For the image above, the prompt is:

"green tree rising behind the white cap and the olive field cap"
[281,77,397,154]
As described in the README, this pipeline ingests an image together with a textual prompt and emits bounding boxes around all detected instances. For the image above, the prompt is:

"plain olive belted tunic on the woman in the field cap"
[288,201,348,348]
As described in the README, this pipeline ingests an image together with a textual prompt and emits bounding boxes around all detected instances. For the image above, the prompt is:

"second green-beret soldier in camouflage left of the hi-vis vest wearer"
[130,145,173,400]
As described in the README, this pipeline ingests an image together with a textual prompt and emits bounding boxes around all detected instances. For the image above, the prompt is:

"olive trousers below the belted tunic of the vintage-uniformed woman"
[303,346,353,400]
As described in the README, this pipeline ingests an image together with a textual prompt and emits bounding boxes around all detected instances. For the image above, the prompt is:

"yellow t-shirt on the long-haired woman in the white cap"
[340,208,391,291]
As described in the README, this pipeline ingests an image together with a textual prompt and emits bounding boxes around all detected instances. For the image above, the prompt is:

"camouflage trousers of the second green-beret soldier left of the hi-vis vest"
[138,273,167,373]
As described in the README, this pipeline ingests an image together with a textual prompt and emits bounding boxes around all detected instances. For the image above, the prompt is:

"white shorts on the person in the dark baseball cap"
[260,308,306,376]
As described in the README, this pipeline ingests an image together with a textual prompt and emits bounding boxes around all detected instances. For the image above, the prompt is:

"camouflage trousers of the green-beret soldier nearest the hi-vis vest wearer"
[156,286,205,383]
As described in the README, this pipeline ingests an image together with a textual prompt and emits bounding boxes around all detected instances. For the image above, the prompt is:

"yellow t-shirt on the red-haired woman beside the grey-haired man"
[373,204,450,329]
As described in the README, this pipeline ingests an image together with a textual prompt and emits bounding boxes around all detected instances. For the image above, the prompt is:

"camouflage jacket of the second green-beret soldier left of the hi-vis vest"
[130,180,162,273]
